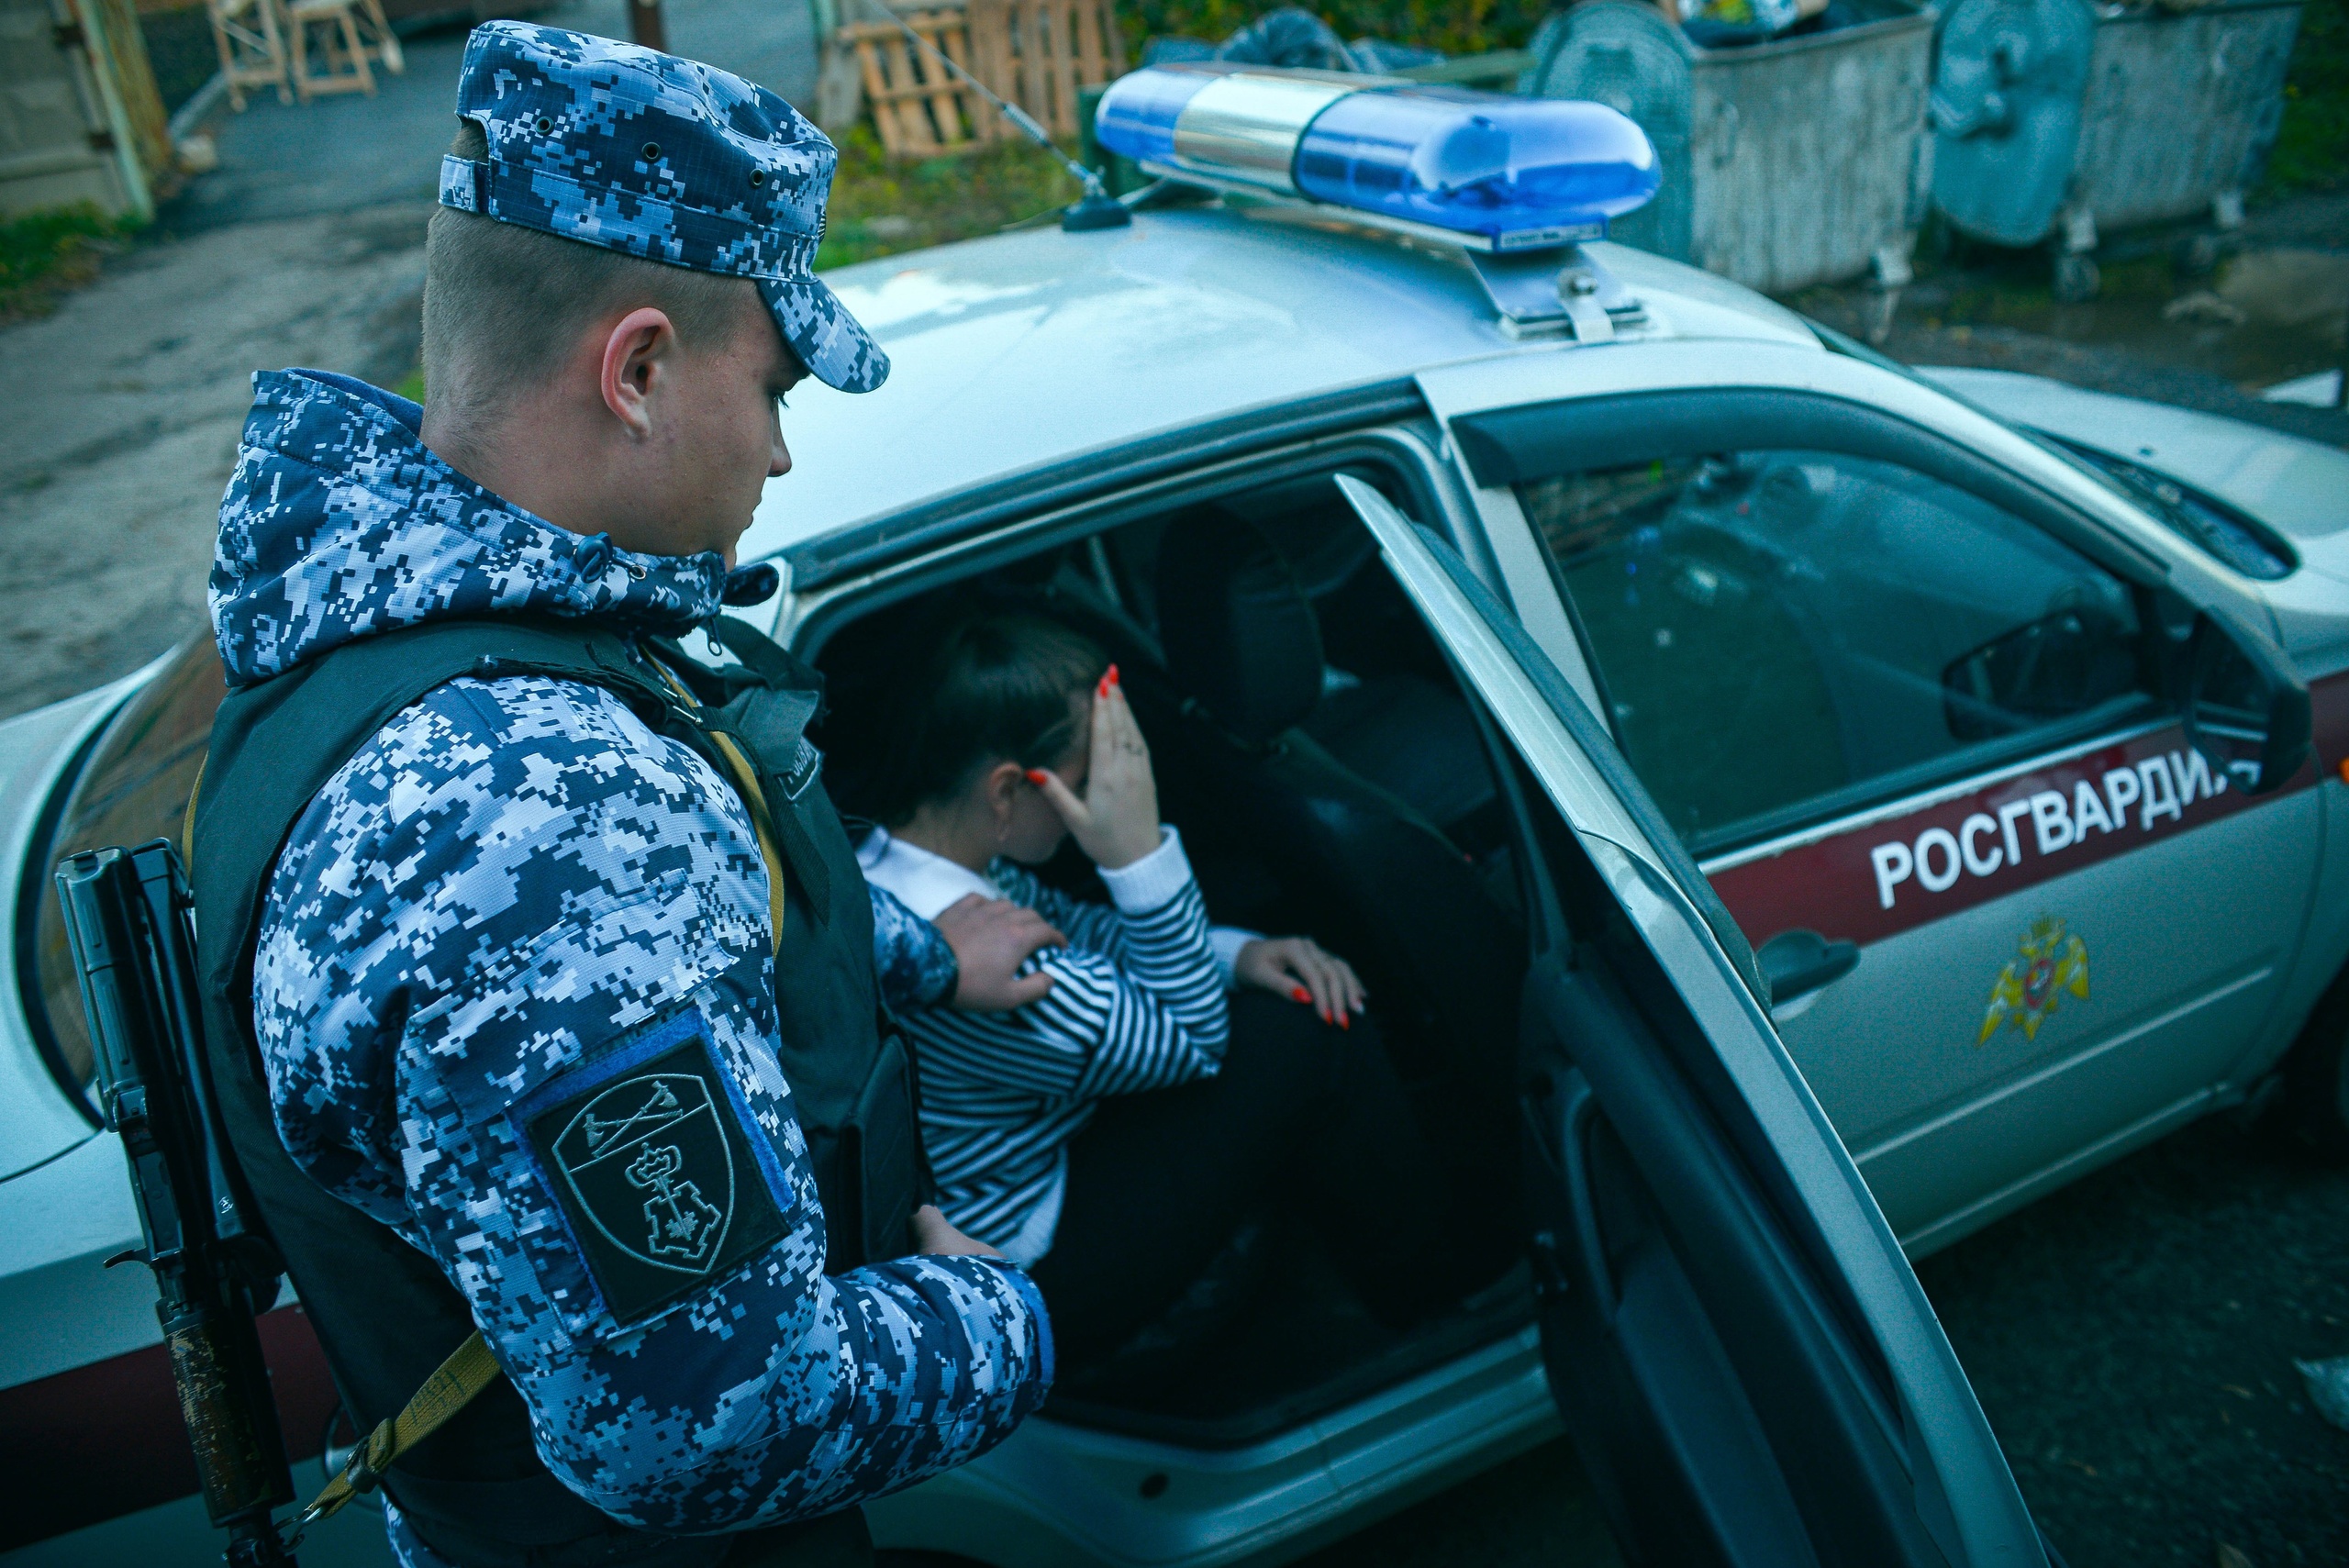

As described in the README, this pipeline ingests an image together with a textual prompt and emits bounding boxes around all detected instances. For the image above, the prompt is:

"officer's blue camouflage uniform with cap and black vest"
[193,21,1052,1568]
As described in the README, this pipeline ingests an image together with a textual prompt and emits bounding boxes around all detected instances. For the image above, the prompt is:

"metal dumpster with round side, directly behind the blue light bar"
[1520,0,1933,291]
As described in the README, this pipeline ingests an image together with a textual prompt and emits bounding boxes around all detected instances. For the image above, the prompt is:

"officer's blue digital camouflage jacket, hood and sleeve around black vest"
[211,371,1052,1565]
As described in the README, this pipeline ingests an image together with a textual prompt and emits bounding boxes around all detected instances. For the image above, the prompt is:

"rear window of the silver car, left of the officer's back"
[18,636,228,1096]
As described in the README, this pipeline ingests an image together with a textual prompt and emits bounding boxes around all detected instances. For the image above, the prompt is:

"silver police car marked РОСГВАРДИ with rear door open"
[0,71,2349,1565]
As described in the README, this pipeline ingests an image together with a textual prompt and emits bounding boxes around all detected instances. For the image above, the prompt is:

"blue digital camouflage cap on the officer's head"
[440,21,888,392]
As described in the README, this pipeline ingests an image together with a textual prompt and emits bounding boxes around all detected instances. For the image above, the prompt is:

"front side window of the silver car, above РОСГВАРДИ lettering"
[1515,449,2147,850]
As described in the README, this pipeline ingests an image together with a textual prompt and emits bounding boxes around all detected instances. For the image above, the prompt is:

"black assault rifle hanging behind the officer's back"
[56,838,294,1568]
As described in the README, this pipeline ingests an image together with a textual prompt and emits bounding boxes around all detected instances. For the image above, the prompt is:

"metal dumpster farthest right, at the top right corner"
[1933,0,2299,298]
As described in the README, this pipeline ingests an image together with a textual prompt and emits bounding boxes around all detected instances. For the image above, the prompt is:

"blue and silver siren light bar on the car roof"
[1095,63,1661,343]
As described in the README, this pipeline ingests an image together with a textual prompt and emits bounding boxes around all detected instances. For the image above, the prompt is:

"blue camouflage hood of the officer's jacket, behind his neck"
[211,371,726,685]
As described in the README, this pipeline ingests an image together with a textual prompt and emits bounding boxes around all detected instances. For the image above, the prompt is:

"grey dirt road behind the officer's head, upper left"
[0,0,815,718]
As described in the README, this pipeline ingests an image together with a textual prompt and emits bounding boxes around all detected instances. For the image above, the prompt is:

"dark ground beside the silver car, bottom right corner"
[1917,1115,2349,1568]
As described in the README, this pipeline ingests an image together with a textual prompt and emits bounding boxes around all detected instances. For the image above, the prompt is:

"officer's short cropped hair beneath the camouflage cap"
[425,119,756,413]
